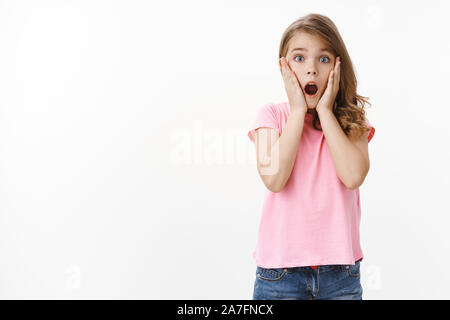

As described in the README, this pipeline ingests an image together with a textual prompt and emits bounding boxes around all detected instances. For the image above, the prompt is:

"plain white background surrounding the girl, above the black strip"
[0,0,450,299]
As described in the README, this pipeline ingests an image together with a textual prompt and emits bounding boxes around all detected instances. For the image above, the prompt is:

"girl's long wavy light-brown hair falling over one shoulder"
[279,13,371,137]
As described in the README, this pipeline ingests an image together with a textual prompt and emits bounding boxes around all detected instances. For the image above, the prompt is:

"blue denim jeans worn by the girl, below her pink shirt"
[253,260,363,300]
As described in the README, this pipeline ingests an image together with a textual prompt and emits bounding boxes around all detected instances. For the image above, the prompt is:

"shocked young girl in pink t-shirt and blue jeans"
[248,14,375,299]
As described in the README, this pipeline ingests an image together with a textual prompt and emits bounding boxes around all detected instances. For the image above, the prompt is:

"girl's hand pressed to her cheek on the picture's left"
[279,57,308,113]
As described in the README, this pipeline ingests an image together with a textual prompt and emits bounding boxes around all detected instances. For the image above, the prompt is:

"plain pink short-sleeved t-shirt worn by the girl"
[248,102,375,268]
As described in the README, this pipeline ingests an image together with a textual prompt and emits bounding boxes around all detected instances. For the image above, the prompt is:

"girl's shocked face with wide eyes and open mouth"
[286,32,335,109]
